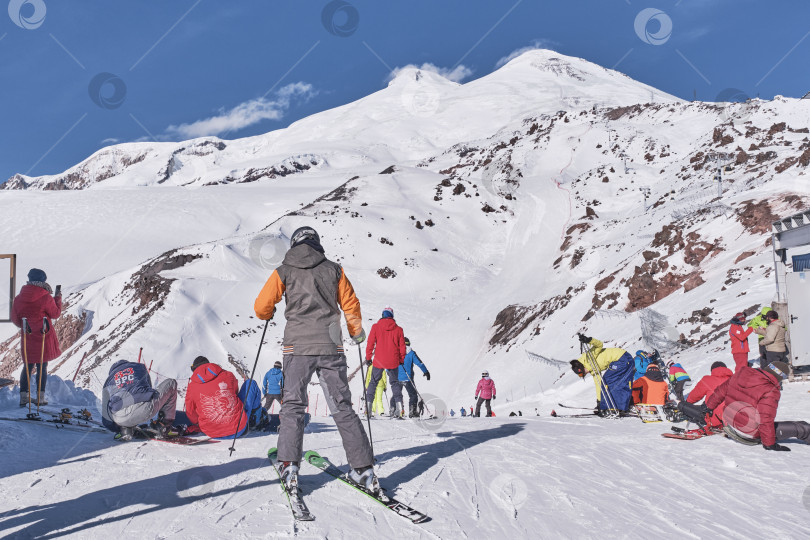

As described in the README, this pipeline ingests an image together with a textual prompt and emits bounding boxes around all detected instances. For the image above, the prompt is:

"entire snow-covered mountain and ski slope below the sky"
[0,50,810,538]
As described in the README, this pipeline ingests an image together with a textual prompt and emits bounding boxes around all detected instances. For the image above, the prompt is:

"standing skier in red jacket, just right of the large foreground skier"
[366,307,407,418]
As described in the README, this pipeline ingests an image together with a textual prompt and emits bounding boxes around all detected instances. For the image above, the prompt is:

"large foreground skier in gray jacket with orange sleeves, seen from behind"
[254,227,380,492]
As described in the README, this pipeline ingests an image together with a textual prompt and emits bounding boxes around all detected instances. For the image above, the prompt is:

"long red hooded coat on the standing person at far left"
[11,285,62,364]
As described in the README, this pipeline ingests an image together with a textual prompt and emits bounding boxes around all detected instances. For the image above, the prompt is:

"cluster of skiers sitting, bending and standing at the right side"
[571,307,810,451]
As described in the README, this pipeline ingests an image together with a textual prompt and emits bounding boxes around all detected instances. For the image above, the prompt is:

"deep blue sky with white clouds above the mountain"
[0,0,810,182]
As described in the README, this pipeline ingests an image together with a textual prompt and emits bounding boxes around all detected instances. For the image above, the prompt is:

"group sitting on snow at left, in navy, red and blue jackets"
[101,356,284,441]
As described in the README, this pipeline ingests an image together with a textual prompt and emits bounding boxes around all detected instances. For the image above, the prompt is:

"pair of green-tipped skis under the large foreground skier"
[267,448,430,523]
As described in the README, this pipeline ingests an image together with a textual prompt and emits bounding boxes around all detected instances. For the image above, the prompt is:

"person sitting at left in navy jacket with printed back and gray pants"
[101,360,177,441]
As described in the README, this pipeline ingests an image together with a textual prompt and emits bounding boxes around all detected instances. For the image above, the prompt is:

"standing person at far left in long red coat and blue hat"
[11,268,62,407]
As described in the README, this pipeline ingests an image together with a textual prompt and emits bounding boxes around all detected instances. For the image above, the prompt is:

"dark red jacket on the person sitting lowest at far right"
[706,366,782,446]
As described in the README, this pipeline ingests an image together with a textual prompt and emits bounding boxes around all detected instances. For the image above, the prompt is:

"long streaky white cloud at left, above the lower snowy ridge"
[166,82,317,139]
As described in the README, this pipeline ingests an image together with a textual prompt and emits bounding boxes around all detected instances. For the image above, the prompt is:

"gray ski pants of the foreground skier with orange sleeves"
[278,354,374,469]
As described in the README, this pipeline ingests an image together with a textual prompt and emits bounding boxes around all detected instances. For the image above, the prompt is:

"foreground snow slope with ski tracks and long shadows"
[0,390,810,539]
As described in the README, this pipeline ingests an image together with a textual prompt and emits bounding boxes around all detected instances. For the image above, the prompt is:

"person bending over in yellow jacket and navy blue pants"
[571,334,636,411]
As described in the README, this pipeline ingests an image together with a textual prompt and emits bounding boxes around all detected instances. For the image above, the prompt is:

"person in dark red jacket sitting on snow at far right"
[705,361,810,451]
